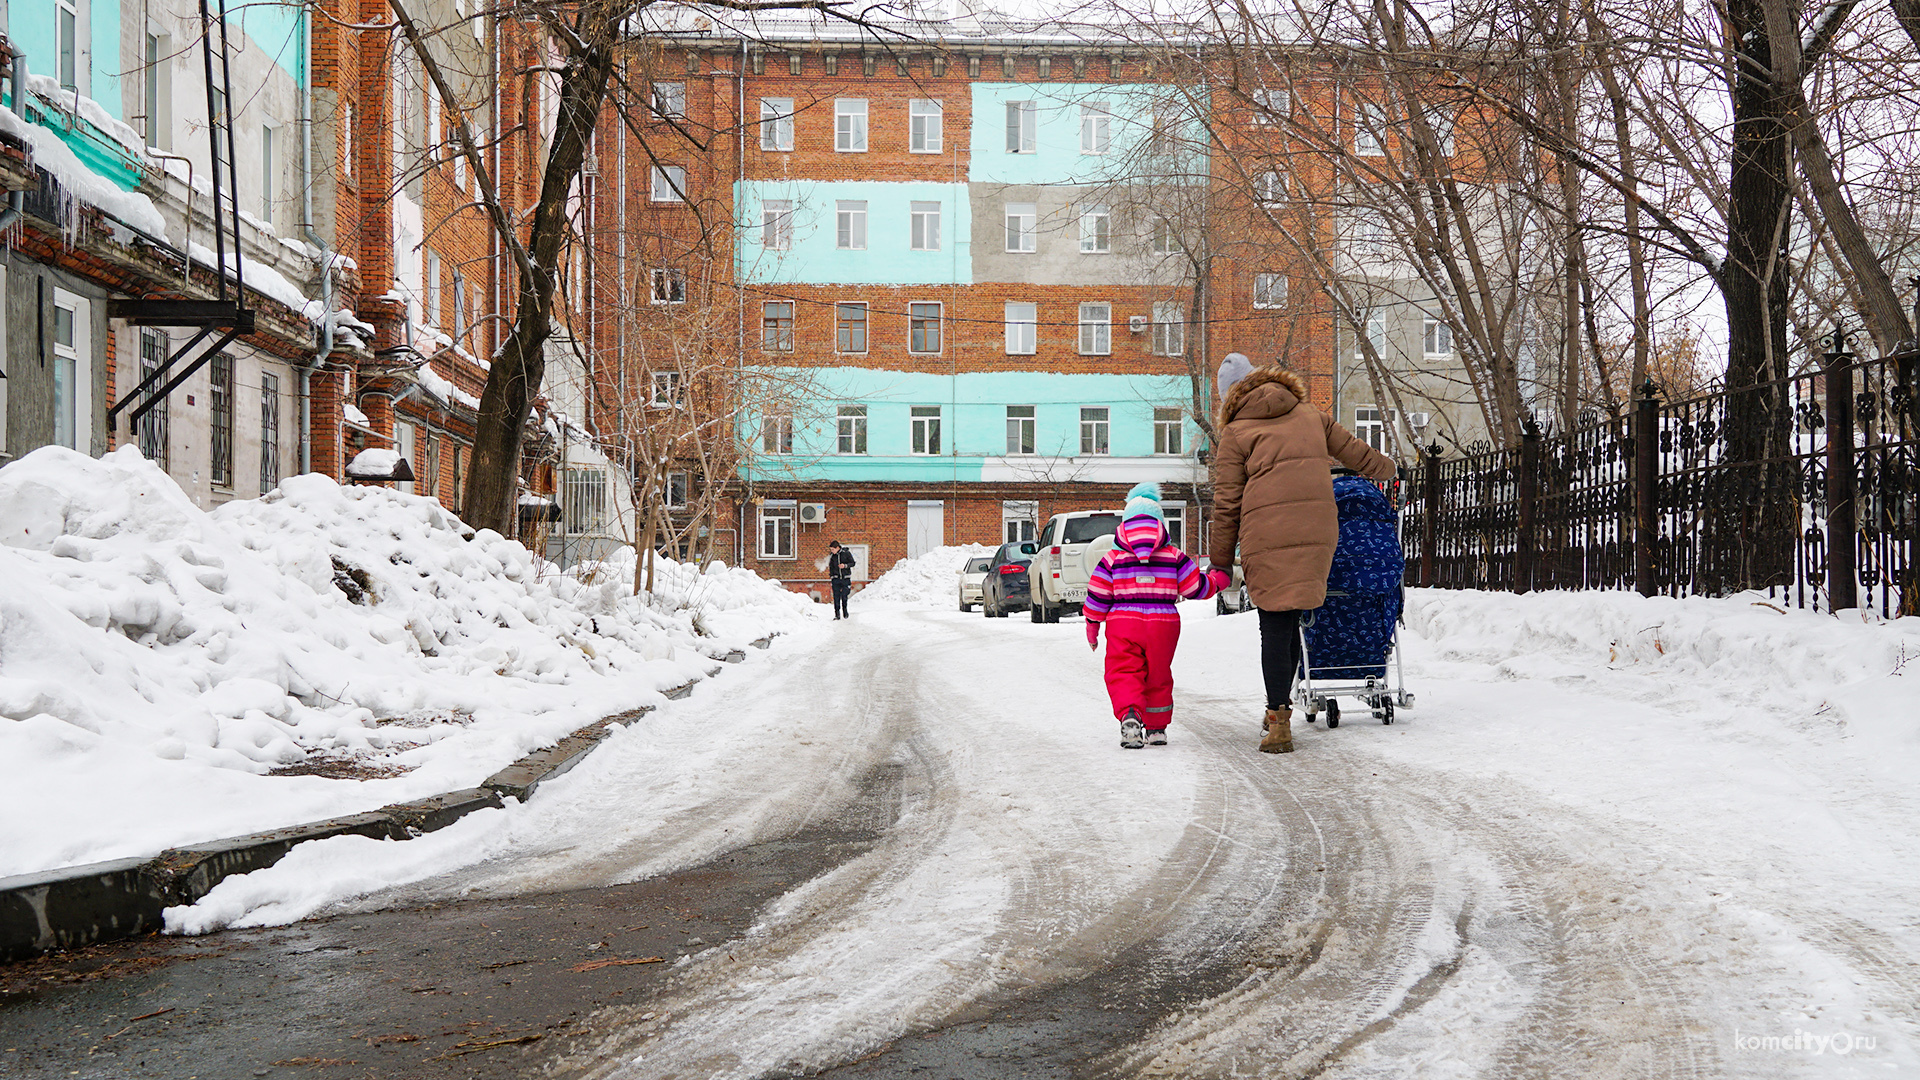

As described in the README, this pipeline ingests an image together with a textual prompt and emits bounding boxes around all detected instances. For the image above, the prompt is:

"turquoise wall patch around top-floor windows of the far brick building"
[968,83,1204,184]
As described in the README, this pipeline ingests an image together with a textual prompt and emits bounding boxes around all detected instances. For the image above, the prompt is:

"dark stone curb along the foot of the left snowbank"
[0,634,778,963]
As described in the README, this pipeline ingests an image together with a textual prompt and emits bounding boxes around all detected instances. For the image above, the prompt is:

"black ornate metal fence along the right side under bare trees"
[1404,343,1920,615]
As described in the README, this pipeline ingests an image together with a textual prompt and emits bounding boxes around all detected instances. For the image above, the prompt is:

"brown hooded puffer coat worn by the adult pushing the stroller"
[1210,365,1394,611]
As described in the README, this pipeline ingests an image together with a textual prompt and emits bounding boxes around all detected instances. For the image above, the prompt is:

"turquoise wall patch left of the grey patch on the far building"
[733,181,973,284]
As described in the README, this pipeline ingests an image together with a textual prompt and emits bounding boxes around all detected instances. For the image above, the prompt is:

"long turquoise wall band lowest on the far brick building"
[745,367,1200,480]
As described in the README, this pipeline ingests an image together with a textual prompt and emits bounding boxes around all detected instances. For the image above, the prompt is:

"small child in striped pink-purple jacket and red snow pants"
[1083,482,1229,749]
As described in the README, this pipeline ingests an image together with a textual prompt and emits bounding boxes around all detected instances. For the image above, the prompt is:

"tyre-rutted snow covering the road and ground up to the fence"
[37,538,1920,1080]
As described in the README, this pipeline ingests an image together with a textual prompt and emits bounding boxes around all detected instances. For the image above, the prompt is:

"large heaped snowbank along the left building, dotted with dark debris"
[0,448,810,876]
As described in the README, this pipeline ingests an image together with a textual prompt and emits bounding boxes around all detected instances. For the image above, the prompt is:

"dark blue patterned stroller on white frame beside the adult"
[1294,471,1413,728]
